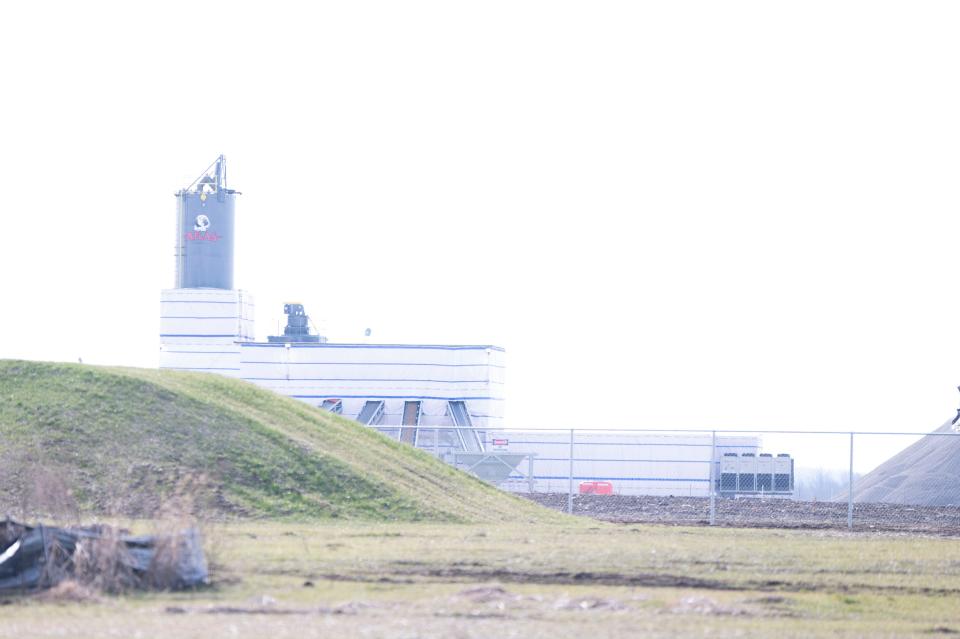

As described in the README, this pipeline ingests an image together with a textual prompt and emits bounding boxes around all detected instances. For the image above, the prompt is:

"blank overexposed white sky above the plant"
[0,0,960,470]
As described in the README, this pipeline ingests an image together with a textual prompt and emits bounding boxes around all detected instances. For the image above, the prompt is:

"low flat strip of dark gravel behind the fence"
[522,493,960,536]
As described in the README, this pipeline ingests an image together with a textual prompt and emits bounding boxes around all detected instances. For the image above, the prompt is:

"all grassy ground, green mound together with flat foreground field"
[0,361,960,639]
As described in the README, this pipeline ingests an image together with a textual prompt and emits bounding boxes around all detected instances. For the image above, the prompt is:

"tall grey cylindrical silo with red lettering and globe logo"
[174,155,240,290]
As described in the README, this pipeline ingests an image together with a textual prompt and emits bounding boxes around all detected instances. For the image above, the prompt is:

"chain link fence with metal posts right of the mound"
[378,424,960,535]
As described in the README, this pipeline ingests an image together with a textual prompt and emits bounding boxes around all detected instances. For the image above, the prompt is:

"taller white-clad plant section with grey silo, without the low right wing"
[160,156,505,440]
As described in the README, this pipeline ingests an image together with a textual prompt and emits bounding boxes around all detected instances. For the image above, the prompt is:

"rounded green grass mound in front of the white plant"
[0,360,558,522]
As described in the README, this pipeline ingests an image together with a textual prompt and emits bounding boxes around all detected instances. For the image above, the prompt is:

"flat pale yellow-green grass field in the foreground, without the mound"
[0,519,960,639]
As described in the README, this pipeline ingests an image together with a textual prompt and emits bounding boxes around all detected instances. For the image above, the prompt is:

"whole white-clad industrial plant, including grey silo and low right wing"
[160,156,792,495]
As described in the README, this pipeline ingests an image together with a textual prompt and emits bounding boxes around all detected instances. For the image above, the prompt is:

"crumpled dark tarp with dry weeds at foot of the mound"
[0,518,208,591]
